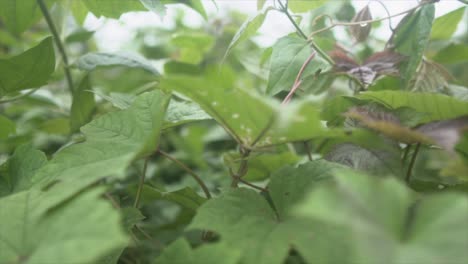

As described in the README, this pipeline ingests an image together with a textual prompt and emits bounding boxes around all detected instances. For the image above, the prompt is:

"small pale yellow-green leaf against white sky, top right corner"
[431,7,466,40]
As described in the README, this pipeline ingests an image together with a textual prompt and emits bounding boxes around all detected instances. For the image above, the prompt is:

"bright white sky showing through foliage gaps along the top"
[85,0,466,52]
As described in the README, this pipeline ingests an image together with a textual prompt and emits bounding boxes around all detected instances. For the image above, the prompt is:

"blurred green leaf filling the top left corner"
[0,0,55,36]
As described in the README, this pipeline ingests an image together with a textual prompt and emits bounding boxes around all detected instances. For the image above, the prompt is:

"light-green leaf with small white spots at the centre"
[160,73,333,146]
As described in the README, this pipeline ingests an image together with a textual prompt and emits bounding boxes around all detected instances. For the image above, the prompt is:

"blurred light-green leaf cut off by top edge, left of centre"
[83,0,145,18]
